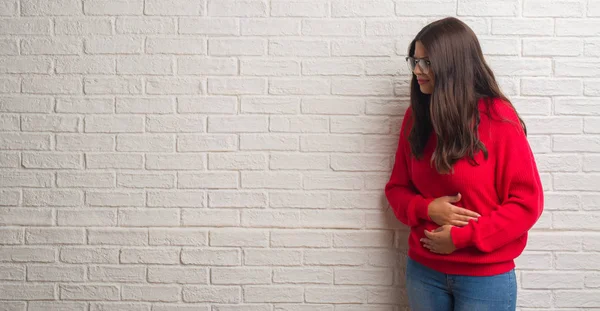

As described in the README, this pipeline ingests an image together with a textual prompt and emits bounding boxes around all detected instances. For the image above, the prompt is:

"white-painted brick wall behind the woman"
[0,0,600,311]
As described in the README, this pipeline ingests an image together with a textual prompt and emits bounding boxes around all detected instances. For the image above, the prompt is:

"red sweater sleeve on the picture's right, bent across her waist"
[451,108,543,252]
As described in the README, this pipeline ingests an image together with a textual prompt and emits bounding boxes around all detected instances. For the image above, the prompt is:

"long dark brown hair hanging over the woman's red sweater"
[408,17,525,173]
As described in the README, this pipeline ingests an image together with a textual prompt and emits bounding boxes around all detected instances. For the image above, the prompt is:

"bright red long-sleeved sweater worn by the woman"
[385,99,543,276]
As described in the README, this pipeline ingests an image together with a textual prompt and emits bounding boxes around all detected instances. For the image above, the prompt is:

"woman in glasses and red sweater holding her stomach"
[385,18,543,311]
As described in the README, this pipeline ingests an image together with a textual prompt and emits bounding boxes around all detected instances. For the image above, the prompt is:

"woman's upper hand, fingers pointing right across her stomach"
[427,193,481,227]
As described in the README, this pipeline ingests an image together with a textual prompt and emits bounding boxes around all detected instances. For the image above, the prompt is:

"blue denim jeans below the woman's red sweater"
[406,258,517,311]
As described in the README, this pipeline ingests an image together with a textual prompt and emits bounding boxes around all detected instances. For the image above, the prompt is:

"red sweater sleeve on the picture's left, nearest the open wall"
[385,108,433,227]
